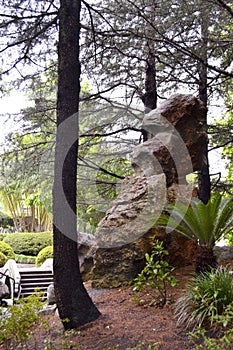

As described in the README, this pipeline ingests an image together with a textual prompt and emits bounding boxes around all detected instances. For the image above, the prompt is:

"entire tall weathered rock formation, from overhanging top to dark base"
[92,94,206,288]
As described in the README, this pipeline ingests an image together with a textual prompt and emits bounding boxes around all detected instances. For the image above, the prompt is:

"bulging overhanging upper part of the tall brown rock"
[132,94,207,186]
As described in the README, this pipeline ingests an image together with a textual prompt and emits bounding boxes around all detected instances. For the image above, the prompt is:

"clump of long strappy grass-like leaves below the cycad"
[175,266,233,329]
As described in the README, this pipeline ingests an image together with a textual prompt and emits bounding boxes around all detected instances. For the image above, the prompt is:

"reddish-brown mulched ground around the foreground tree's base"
[0,266,233,350]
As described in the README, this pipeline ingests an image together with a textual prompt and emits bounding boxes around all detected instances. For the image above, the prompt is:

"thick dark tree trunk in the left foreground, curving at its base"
[53,0,100,329]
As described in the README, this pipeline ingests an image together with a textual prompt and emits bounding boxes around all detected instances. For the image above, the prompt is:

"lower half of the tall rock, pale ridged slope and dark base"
[92,174,166,288]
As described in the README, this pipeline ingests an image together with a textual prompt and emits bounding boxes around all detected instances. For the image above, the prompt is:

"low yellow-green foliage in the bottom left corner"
[0,292,76,350]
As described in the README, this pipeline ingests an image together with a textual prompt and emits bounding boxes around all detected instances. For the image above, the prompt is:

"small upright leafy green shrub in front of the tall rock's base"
[133,240,178,306]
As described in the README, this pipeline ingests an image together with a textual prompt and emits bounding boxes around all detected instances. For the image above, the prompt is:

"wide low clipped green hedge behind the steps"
[4,232,53,256]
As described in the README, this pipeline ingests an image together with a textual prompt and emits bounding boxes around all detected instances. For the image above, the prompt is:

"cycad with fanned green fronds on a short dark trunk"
[156,193,233,273]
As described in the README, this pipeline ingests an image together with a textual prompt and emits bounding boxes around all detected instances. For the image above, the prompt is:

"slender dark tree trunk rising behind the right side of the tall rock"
[198,1,211,204]
